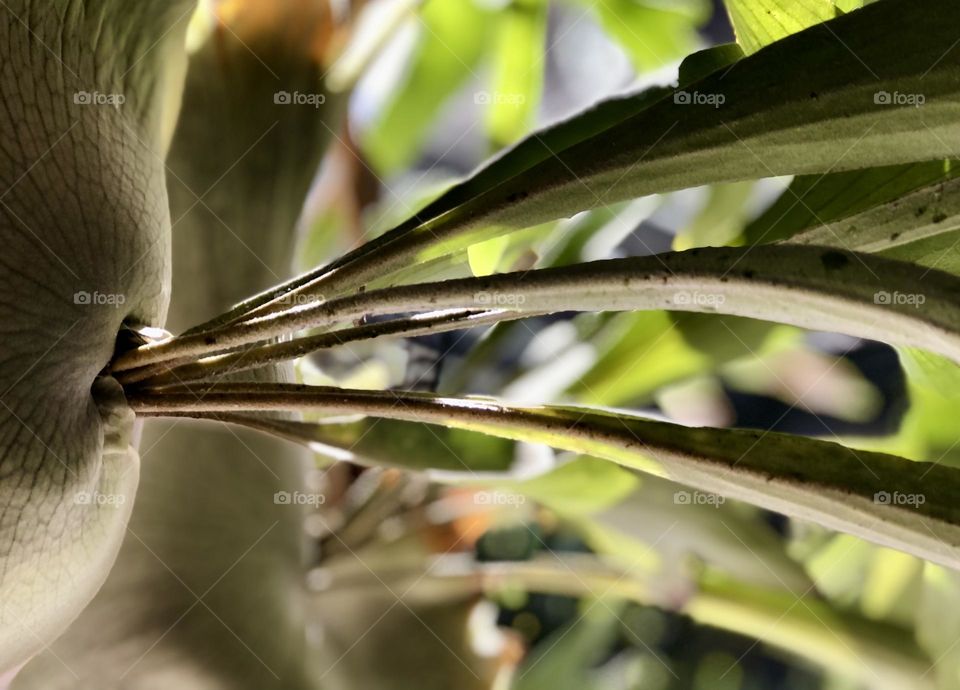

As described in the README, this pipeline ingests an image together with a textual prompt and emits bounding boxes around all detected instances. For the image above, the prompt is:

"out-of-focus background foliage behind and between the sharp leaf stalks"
[180,0,960,690]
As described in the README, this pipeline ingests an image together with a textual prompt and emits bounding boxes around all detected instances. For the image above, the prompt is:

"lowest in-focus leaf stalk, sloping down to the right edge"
[128,384,960,568]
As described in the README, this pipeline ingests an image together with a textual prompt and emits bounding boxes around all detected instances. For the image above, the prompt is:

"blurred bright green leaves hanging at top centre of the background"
[363,0,709,173]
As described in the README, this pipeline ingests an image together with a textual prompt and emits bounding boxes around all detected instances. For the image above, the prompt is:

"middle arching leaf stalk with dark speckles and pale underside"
[113,245,960,372]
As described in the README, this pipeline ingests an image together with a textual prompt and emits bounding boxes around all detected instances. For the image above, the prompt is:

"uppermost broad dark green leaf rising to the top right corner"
[212,0,960,330]
